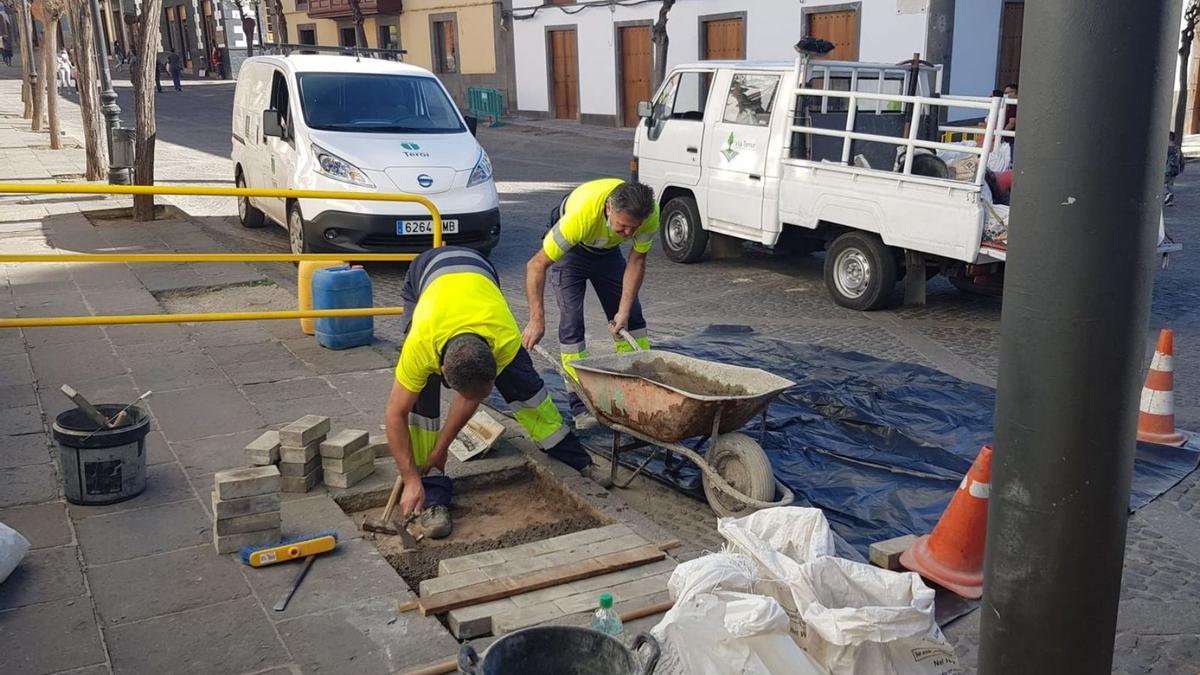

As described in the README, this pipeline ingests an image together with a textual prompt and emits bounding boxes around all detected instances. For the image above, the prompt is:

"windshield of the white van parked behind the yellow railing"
[296,73,466,133]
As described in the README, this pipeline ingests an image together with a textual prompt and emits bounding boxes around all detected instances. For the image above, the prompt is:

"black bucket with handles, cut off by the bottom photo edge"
[458,626,659,675]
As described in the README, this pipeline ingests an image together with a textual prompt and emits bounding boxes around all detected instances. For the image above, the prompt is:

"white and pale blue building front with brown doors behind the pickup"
[512,0,1024,126]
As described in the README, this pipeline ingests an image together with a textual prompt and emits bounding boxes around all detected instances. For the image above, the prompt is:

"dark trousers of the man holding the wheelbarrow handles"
[550,245,646,414]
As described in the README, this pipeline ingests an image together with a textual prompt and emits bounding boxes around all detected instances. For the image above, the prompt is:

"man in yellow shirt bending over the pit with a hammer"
[386,246,604,539]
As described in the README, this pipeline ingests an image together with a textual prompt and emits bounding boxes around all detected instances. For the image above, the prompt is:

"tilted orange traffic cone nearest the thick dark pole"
[900,446,991,599]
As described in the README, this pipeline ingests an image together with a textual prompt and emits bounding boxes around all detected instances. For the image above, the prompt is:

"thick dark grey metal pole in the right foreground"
[979,0,1180,675]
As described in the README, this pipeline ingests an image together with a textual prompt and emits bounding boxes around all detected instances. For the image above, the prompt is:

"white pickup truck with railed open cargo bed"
[632,52,1178,310]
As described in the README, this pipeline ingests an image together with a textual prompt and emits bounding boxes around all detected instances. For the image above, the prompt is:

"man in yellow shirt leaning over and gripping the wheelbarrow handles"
[522,178,659,429]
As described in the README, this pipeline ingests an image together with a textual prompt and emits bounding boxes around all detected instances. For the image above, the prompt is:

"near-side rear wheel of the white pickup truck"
[824,232,896,311]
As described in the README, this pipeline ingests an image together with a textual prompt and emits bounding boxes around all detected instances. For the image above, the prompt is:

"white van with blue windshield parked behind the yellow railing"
[233,54,500,255]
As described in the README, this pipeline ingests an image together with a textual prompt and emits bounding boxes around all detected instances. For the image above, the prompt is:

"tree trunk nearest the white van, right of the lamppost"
[133,0,162,222]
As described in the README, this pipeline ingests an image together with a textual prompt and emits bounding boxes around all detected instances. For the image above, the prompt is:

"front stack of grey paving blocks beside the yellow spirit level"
[212,466,281,554]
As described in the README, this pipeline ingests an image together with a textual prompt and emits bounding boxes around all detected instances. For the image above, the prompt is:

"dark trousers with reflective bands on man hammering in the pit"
[400,246,592,506]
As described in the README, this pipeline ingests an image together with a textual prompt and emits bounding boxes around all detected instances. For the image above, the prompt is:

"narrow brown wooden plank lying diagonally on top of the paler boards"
[420,544,666,615]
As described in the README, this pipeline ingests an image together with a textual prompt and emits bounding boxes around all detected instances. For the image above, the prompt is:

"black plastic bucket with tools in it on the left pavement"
[53,404,150,504]
